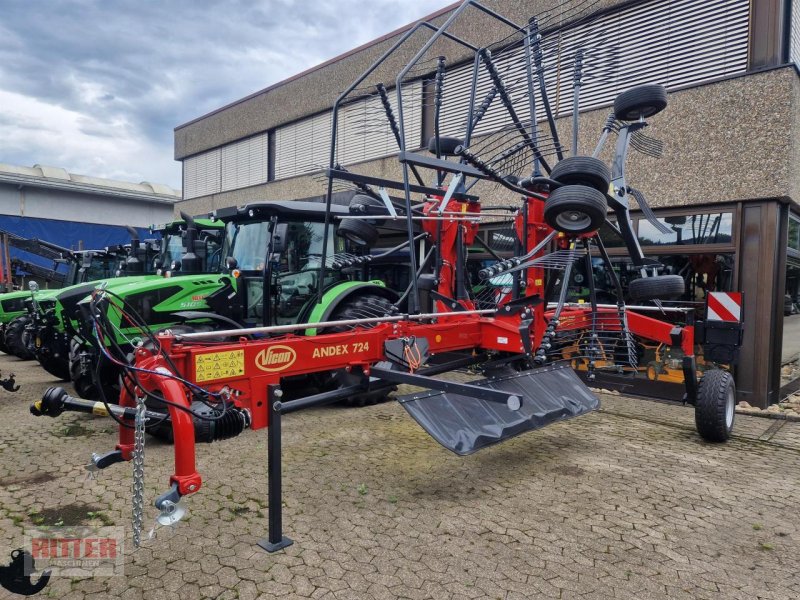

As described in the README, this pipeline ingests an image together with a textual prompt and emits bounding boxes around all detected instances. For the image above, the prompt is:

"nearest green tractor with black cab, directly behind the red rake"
[73,201,399,404]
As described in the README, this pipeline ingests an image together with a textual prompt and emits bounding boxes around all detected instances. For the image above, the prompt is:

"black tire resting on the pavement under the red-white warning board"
[694,369,736,443]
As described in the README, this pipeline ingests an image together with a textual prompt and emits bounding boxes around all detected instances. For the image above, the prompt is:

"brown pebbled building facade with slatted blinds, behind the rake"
[175,0,800,406]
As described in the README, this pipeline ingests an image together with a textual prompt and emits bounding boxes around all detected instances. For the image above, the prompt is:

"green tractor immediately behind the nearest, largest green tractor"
[26,221,221,392]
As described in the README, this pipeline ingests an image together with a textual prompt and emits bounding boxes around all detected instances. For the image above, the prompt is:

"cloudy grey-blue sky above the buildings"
[0,0,450,188]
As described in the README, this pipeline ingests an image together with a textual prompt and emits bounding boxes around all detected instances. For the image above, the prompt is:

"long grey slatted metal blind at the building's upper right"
[441,0,752,136]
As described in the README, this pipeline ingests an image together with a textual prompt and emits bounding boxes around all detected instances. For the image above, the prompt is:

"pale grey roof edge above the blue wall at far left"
[0,184,173,227]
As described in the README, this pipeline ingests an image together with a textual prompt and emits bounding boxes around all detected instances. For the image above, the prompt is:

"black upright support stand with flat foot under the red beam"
[258,384,294,552]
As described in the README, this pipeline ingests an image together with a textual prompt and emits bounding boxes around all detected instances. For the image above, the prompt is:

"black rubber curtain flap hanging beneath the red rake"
[398,365,600,456]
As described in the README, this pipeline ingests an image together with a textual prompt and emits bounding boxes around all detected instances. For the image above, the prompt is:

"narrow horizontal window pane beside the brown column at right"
[639,212,733,246]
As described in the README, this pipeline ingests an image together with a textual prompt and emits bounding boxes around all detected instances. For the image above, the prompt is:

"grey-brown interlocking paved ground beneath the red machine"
[0,355,800,600]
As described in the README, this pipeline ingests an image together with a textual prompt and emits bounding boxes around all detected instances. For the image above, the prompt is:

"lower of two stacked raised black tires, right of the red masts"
[544,185,608,235]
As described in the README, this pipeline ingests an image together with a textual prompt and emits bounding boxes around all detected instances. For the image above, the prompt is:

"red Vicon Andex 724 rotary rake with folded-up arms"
[31,0,735,551]
